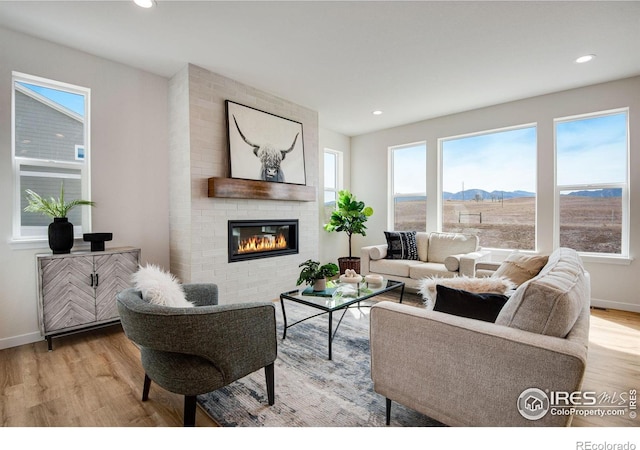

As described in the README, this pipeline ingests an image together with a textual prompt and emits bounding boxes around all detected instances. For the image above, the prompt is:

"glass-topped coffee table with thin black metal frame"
[280,279,404,359]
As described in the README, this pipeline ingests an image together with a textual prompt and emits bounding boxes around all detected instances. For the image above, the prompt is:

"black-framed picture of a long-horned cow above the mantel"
[225,100,306,185]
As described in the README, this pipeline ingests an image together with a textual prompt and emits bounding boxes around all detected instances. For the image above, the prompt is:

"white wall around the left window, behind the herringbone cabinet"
[0,28,169,348]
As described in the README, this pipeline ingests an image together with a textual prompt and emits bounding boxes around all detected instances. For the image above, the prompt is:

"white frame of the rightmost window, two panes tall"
[553,107,631,260]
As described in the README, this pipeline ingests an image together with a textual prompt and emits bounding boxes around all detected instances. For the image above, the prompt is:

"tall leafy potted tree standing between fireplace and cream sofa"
[324,190,373,274]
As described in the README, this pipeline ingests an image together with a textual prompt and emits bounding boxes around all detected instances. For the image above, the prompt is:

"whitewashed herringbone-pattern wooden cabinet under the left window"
[36,247,140,350]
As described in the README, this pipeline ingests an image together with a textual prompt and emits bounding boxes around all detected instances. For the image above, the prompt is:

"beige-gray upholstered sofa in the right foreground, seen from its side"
[370,248,590,426]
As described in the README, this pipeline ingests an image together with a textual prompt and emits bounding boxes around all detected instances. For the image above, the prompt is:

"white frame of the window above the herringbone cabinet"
[10,71,91,244]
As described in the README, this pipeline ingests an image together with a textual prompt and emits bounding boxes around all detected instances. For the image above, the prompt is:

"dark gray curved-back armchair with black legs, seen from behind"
[116,284,277,426]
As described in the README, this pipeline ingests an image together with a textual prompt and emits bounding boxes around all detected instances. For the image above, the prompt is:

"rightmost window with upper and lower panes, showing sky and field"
[555,110,629,256]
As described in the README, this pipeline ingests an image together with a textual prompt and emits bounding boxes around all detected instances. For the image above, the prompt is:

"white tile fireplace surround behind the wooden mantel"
[169,65,320,304]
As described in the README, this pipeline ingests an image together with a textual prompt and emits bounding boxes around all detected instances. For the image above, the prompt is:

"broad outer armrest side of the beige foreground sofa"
[370,301,587,426]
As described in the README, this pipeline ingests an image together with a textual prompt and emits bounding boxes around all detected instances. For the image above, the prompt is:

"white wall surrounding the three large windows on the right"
[351,77,640,312]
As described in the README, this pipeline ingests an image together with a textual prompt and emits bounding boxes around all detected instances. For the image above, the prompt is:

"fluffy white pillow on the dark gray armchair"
[131,264,195,308]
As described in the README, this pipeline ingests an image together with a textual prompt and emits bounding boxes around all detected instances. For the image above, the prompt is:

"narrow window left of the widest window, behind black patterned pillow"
[388,142,427,231]
